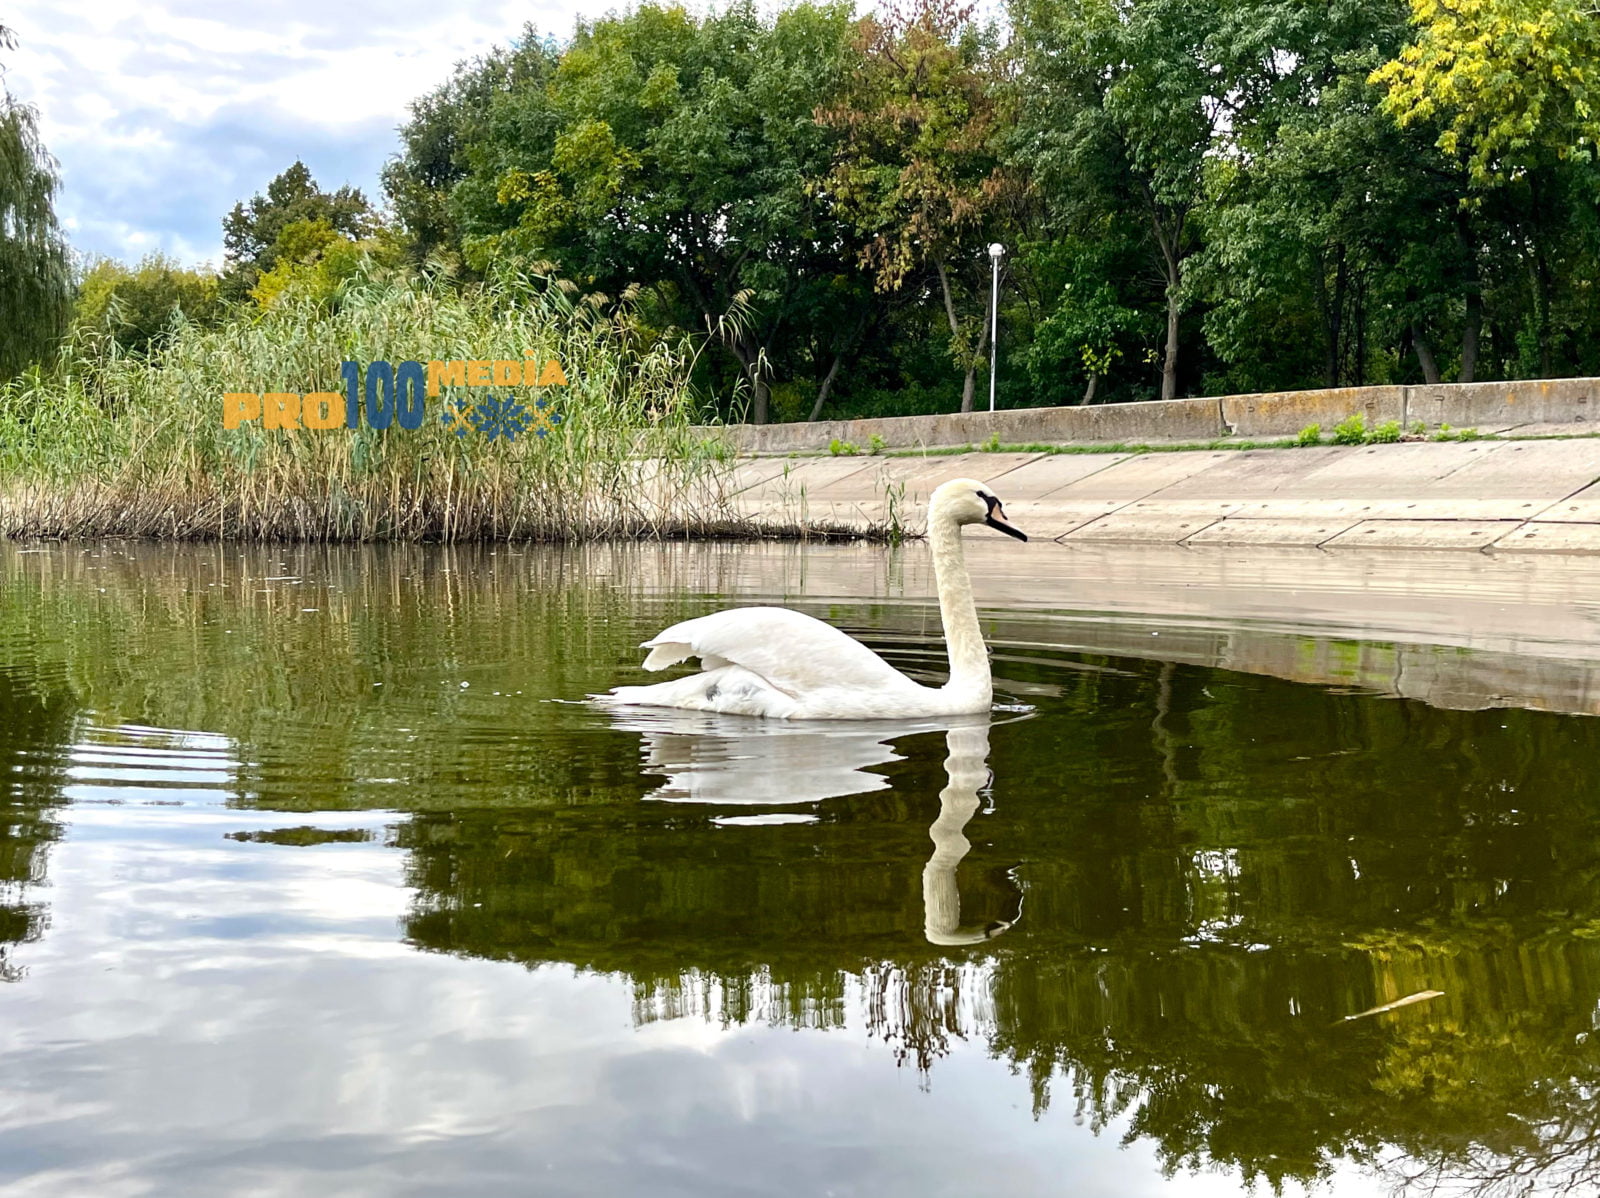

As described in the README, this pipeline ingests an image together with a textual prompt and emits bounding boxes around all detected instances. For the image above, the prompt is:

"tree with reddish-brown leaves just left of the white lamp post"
[818,0,1013,411]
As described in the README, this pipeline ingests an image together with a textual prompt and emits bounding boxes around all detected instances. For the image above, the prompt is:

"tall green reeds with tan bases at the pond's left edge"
[0,274,738,541]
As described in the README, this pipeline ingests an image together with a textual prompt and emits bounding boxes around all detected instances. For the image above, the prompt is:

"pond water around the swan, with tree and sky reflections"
[0,544,1600,1198]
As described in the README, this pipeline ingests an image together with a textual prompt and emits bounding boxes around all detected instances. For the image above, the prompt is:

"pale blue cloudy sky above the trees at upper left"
[0,0,621,264]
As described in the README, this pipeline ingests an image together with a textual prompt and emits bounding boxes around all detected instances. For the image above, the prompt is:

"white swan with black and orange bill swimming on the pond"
[597,478,1027,720]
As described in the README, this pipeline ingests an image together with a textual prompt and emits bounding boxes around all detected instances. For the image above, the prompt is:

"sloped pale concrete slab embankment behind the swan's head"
[733,437,1600,553]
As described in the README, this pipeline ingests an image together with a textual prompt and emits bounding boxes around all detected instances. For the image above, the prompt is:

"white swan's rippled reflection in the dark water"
[611,709,1022,947]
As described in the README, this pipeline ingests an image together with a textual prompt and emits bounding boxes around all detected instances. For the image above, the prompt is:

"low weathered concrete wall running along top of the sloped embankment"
[704,379,1600,454]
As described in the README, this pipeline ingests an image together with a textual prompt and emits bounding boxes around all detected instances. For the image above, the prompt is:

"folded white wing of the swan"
[640,608,915,696]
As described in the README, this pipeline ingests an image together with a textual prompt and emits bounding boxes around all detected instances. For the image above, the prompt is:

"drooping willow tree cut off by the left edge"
[0,26,72,381]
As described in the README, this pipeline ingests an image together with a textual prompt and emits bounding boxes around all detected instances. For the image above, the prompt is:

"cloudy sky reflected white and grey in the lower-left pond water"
[0,716,1356,1198]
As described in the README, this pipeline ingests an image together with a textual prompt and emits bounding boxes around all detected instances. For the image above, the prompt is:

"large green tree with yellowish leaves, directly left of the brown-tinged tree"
[389,3,867,422]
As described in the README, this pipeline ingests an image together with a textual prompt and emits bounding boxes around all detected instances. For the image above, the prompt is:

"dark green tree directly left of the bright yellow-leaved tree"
[1192,0,1475,390]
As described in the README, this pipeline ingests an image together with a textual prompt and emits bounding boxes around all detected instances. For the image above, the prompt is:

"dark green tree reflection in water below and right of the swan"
[402,662,1600,1187]
